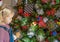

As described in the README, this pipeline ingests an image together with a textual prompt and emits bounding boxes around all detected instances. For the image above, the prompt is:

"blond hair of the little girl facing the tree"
[0,7,14,23]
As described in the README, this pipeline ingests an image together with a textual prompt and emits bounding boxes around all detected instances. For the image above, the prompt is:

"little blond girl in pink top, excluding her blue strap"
[0,8,14,42]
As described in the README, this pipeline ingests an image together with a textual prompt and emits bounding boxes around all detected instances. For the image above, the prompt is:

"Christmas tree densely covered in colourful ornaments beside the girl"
[10,0,60,42]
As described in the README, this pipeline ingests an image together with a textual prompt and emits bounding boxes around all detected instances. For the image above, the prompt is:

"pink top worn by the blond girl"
[0,25,10,42]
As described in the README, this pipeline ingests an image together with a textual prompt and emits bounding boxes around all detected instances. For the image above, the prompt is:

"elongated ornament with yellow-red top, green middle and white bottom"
[27,22,38,38]
